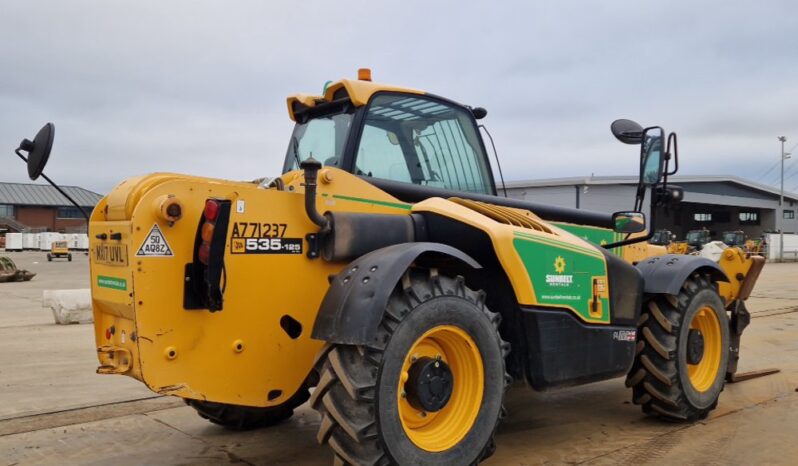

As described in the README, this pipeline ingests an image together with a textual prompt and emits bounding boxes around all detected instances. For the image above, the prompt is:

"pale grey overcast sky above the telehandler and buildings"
[0,0,798,193]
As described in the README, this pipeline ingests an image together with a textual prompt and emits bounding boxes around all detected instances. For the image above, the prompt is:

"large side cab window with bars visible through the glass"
[355,94,491,194]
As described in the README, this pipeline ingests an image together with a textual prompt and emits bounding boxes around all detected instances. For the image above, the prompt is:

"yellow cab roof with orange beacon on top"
[287,70,426,121]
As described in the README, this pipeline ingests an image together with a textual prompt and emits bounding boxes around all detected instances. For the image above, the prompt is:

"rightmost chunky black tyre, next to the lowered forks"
[626,274,729,422]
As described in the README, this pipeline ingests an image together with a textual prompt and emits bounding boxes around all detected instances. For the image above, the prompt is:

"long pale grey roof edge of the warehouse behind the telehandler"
[505,175,798,200]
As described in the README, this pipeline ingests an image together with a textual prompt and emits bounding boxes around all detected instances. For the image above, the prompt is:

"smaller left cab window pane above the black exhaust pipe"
[286,113,352,171]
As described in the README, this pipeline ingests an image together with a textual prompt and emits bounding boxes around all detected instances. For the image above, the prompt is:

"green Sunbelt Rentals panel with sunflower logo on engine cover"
[513,233,610,323]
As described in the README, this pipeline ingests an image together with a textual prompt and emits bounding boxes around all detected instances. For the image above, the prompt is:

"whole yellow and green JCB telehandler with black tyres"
[17,71,762,465]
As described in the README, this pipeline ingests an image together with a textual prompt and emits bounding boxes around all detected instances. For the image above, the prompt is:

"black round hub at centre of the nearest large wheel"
[405,357,453,413]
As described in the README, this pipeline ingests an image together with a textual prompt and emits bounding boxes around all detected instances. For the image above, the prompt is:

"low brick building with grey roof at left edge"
[0,182,102,234]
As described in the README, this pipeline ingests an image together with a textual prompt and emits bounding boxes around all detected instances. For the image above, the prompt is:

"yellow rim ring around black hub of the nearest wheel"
[397,325,485,452]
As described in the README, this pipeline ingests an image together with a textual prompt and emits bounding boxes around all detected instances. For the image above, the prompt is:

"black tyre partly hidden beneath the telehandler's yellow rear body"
[184,384,310,430]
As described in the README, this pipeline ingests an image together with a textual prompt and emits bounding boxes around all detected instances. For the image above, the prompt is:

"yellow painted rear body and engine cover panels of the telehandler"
[89,168,688,406]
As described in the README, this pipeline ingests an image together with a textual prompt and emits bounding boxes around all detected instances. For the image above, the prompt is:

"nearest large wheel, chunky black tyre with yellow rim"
[311,269,509,465]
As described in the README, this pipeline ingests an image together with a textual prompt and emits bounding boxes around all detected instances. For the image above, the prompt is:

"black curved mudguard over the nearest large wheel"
[311,243,482,346]
